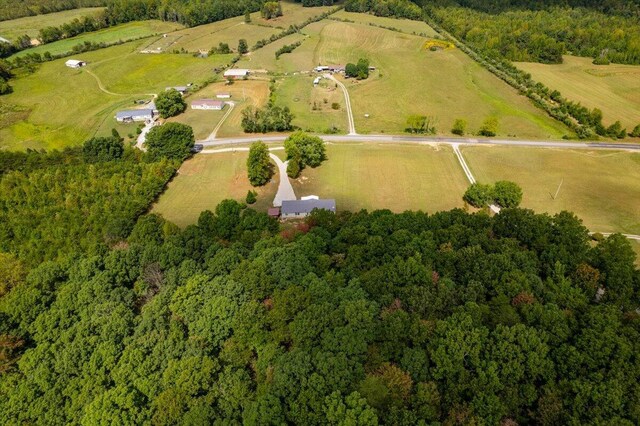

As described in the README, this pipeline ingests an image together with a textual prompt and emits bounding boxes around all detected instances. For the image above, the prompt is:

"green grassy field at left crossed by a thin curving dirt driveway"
[0,41,229,149]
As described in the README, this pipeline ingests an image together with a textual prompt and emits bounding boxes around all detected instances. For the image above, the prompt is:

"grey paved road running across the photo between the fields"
[198,135,640,152]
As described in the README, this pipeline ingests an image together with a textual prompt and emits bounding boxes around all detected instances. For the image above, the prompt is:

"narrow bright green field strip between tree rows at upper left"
[11,21,182,58]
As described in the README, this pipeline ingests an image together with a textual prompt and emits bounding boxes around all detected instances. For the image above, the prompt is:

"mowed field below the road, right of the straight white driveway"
[462,147,640,234]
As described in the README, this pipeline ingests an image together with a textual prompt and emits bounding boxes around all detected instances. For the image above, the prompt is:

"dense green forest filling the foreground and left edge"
[0,141,640,425]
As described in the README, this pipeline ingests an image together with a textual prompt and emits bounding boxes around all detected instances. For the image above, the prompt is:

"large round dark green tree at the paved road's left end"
[145,123,195,161]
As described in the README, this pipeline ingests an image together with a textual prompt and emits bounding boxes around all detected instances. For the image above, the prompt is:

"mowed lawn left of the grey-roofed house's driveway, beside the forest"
[152,151,279,227]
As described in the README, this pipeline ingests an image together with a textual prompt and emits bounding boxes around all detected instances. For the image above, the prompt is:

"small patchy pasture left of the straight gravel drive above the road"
[276,74,349,133]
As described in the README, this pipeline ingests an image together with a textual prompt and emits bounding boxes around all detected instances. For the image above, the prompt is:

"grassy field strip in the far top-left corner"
[0,7,104,41]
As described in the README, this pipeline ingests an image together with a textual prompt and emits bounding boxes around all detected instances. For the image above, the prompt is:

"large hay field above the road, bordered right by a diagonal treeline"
[313,22,569,139]
